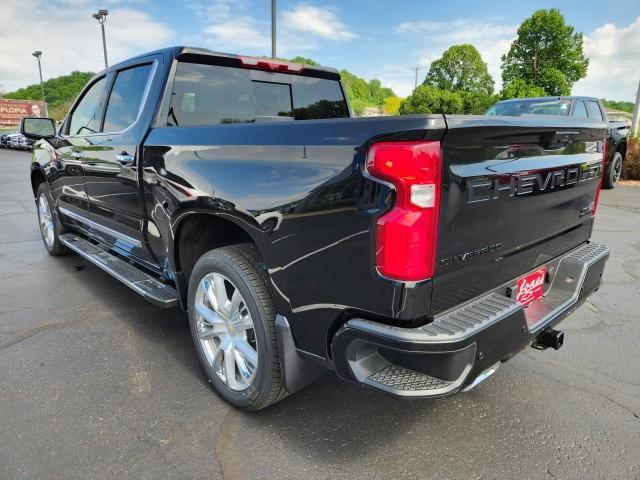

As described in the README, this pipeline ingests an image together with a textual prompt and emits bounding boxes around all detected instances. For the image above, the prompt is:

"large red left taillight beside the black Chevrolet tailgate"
[367,142,442,281]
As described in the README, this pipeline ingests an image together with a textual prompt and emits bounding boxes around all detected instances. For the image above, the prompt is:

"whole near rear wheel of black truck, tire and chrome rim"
[188,244,287,410]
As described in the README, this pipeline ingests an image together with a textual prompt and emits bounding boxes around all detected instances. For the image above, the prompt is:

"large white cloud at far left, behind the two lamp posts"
[0,0,174,91]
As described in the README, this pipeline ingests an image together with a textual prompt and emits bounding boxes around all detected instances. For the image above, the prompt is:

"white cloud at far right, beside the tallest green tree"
[572,17,640,101]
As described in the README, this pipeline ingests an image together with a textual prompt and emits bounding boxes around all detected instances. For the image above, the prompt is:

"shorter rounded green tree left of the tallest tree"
[425,44,493,96]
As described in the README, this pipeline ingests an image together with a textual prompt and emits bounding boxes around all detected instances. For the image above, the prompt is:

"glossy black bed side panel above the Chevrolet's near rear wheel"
[143,116,444,356]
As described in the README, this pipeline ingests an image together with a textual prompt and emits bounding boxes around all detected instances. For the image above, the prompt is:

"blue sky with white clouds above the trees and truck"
[0,0,640,101]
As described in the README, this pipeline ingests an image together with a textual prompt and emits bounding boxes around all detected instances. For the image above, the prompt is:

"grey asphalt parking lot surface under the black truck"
[0,150,640,479]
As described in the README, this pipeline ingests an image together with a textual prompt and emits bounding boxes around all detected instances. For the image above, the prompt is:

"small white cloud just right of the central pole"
[282,5,356,40]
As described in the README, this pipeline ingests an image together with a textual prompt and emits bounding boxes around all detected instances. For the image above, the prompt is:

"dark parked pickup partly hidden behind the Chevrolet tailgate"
[486,96,630,188]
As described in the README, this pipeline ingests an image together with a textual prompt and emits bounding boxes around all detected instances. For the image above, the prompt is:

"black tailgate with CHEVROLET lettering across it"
[432,116,606,313]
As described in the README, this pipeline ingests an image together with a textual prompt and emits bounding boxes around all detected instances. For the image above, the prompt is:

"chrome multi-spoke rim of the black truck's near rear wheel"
[195,273,258,391]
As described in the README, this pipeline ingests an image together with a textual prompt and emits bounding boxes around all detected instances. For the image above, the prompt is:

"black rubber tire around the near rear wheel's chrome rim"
[188,244,287,410]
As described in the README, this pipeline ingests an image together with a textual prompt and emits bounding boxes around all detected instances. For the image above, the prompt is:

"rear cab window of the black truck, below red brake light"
[166,62,349,126]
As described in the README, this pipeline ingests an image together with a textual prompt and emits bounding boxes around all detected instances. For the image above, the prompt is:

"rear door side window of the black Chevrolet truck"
[102,64,151,132]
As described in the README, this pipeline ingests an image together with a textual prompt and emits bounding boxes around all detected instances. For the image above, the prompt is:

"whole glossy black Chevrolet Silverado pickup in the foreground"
[21,47,609,410]
